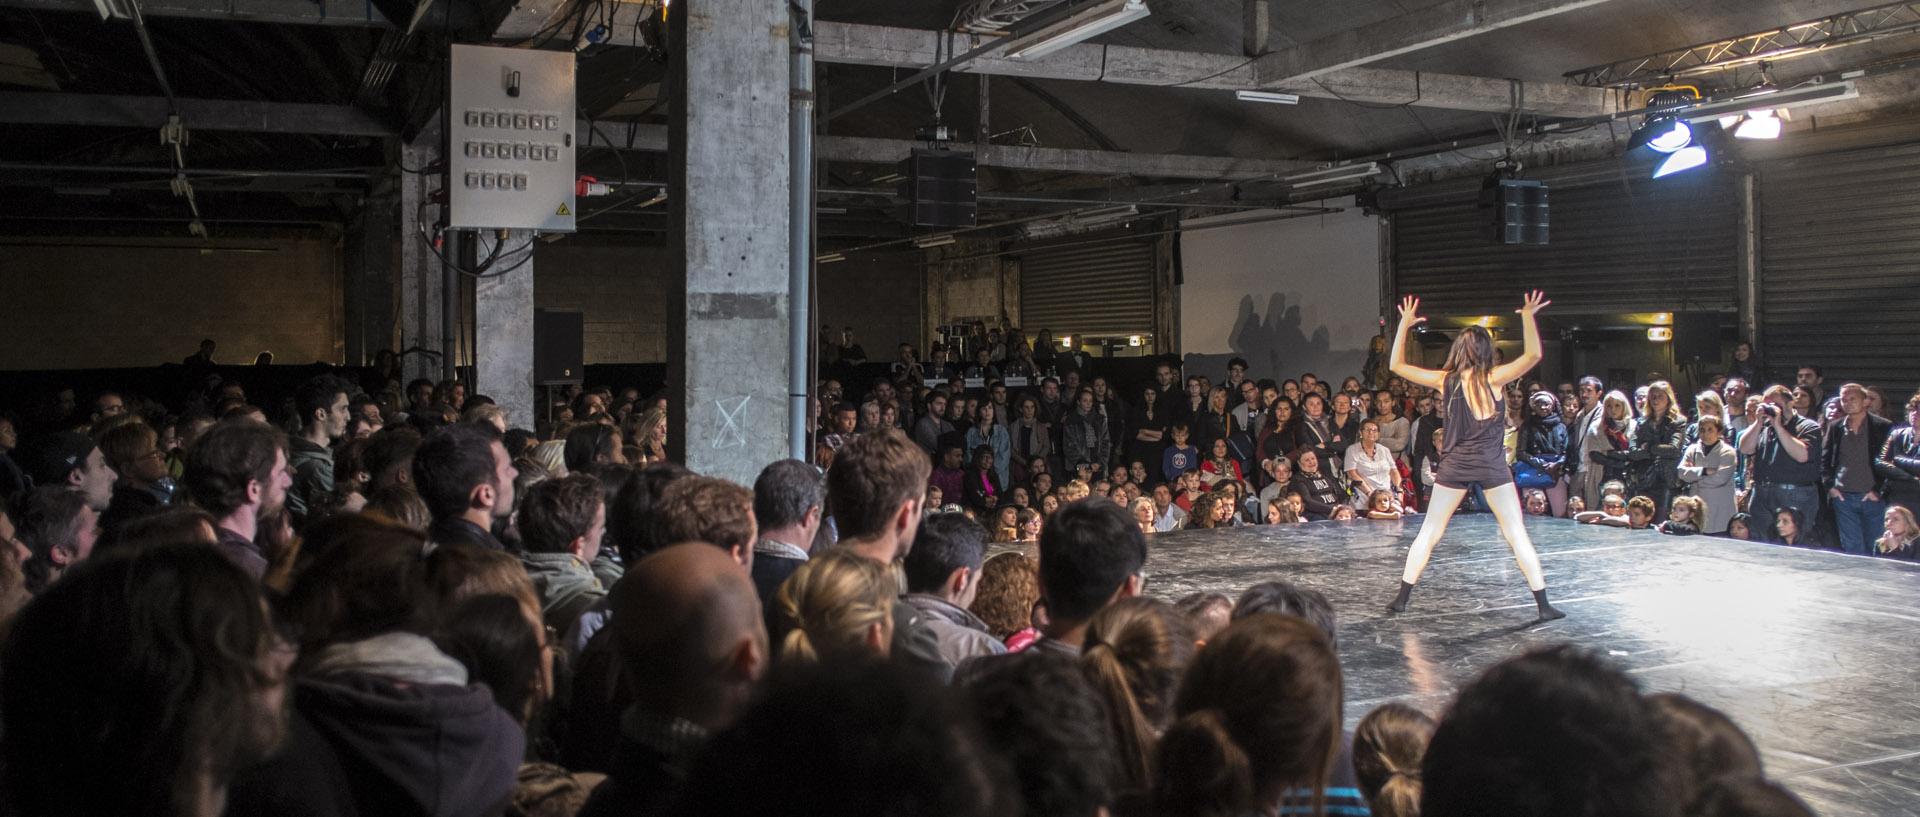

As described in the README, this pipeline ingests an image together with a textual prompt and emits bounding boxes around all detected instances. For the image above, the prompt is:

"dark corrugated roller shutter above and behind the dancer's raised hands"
[1392,171,1740,315]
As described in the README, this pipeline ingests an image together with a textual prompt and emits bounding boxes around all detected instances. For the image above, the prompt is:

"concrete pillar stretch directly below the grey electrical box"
[474,230,534,428]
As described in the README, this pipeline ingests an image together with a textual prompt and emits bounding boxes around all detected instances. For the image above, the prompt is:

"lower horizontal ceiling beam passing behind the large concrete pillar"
[576,119,1317,180]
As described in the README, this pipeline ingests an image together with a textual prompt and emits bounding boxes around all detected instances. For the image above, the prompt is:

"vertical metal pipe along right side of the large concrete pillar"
[787,0,814,460]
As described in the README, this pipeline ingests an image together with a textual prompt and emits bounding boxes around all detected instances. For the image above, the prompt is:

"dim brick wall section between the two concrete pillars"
[534,238,668,362]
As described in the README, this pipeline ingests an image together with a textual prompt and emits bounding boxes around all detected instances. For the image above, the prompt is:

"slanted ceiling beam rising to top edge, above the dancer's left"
[1254,0,1607,88]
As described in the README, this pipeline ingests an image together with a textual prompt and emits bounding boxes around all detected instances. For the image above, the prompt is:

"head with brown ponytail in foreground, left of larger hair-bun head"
[1081,596,1194,790]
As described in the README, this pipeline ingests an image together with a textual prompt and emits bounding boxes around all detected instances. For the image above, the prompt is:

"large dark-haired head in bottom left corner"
[0,545,288,817]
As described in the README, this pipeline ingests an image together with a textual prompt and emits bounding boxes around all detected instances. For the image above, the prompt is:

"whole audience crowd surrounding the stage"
[0,326,1889,817]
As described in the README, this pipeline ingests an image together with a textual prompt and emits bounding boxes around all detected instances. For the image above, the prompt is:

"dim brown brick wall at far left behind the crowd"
[0,238,346,370]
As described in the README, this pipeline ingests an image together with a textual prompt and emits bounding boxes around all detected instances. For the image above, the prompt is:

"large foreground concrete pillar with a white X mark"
[666,0,791,485]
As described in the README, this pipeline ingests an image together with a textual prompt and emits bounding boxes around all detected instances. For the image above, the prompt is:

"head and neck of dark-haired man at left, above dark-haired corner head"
[182,422,291,581]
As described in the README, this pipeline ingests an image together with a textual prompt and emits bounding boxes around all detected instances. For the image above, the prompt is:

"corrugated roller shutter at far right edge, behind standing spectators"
[1759,144,1920,393]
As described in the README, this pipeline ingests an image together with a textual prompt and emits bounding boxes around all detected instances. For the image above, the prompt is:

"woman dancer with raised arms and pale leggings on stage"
[1386,290,1567,621]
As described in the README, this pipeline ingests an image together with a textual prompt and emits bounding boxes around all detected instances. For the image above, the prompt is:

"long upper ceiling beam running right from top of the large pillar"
[814,23,1617,117]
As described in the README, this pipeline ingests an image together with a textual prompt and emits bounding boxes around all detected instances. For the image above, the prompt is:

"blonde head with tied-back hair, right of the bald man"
[774,550,899,662]
